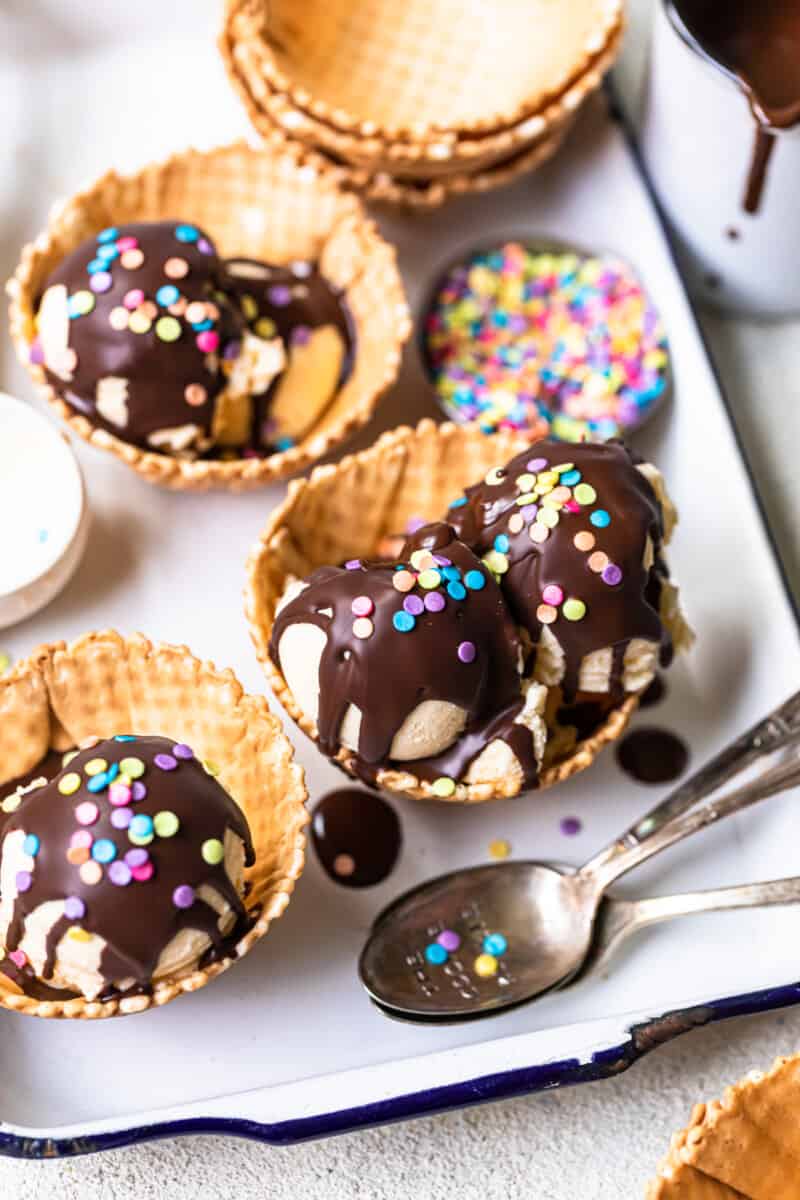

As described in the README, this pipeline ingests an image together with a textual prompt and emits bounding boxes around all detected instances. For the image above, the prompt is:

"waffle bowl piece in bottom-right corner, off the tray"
[646,1055,800,1200]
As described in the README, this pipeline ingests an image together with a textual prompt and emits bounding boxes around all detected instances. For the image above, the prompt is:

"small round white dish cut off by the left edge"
[0,392,89,629]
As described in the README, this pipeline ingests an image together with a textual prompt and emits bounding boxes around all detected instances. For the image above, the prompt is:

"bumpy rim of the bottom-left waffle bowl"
[0,629,311,1020]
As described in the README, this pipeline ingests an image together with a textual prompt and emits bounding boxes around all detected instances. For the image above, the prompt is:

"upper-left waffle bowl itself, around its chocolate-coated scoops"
[8,138,410,491]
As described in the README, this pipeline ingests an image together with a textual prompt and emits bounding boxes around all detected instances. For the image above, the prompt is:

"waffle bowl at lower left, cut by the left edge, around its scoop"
[0,632,308,1019]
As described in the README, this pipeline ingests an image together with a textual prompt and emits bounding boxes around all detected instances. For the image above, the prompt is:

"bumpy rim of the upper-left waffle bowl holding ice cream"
[6,138,413,492]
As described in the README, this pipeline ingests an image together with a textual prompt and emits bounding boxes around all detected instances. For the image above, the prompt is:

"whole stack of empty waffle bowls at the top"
[221,0,622,206]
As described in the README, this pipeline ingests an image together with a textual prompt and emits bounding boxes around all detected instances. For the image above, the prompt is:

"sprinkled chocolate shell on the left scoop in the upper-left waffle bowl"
[32,220,243,446]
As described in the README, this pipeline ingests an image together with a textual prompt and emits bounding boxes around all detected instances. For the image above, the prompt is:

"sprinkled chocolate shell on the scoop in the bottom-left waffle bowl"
[1,736,253,998]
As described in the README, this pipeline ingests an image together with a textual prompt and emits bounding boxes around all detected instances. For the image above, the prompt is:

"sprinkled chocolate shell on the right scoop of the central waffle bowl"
[446,440,672,701]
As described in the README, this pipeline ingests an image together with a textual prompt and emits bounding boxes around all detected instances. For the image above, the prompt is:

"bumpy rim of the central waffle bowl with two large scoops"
[245,419,638,804]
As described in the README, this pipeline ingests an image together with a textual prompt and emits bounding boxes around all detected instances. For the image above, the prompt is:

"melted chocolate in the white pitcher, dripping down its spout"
[668,0,800,212]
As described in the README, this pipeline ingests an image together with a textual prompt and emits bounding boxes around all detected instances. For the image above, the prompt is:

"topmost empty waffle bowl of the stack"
[222,0,622,145]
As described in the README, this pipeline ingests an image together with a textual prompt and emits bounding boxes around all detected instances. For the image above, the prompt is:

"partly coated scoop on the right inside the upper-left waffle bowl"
[222,258,354,448]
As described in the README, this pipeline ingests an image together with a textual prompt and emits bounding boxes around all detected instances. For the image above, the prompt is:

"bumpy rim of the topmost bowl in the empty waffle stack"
[219,0,625,146]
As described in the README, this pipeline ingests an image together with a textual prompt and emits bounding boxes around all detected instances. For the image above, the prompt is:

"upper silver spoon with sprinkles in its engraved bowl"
[359,692,800,1021]
